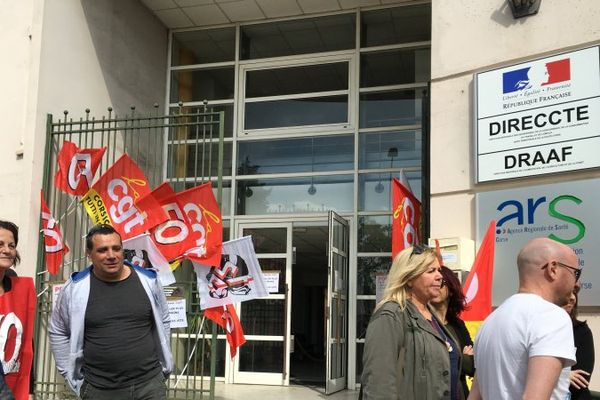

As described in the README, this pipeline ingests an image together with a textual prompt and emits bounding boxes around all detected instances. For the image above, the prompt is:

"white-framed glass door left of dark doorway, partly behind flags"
[233,222,292,385]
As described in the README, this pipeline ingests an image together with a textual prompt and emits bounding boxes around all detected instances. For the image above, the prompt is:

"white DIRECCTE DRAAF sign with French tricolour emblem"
[475,47,600,182]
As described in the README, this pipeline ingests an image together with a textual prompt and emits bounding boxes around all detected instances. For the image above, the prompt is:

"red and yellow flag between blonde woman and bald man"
[460,221,496,337]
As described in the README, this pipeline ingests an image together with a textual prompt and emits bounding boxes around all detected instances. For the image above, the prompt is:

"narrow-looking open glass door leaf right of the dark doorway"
[325,211,350,394]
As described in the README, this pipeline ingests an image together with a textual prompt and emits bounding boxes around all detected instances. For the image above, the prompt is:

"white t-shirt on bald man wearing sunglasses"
[474,293,575,400]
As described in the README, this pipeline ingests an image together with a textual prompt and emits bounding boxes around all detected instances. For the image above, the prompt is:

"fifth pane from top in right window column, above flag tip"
[358,171,421,211]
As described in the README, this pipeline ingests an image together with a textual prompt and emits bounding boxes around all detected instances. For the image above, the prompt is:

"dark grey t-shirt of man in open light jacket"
[83,267,161,389]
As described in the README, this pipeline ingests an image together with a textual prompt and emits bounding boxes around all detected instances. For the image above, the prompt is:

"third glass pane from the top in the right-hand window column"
[360,89,424,128]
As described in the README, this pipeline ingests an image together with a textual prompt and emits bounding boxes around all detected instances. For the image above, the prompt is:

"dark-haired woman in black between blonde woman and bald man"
[431,266,475,398]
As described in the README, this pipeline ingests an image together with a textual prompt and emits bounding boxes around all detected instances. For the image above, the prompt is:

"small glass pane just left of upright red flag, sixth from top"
[358,215,392,253]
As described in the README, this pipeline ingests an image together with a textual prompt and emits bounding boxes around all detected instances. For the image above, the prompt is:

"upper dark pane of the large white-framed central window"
[246,62,348,98]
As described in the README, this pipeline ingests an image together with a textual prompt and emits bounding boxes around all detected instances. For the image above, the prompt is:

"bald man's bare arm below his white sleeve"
[523,356,564,400]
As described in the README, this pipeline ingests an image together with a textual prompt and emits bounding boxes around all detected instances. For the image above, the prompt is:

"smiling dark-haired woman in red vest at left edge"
[0,220,36,400]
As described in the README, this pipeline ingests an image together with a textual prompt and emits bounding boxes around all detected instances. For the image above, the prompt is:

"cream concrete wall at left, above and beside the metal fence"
[0,0,168,276]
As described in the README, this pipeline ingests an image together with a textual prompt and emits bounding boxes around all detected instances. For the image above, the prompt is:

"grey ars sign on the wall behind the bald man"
[475,179,600,306]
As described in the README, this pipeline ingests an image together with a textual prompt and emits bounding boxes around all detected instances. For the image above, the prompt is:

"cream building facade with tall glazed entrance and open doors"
[0,0,600,389]
